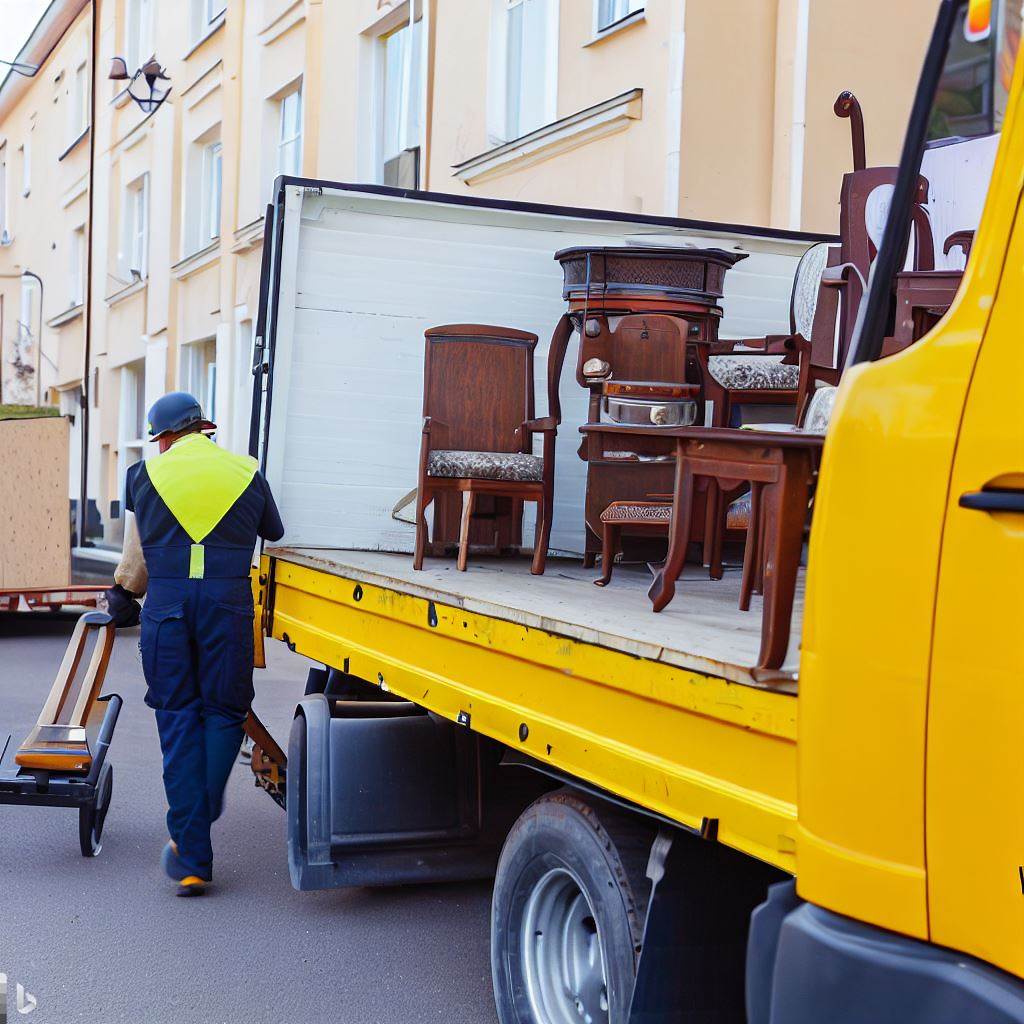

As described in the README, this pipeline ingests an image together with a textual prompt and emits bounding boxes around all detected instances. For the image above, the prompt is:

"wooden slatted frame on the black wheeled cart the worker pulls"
[14,611,114,774]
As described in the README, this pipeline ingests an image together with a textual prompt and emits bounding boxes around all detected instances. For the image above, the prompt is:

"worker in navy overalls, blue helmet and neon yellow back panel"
[108,391,285,896]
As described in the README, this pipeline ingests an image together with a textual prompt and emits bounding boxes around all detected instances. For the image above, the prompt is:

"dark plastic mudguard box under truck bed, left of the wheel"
[287,693,498,890]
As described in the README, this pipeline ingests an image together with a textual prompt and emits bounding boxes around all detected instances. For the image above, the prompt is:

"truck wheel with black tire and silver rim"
[490,790,654,1024]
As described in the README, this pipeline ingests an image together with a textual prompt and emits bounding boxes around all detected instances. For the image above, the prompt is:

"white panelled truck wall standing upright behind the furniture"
[267,188,809,553]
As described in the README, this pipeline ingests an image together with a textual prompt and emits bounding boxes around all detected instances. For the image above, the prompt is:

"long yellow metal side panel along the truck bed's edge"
[262,558,797,872]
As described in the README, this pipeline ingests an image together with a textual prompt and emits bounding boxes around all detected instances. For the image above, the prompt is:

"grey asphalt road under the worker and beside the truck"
[0,623,496,1024]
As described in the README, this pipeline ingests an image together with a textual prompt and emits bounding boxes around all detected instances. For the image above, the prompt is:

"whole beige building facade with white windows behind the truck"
[0,0,934,551]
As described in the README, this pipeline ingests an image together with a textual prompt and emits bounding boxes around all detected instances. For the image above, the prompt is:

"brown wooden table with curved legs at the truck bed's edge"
[580,424,824,670]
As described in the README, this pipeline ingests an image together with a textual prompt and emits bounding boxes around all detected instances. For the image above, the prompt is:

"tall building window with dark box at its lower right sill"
[378,20,423,188]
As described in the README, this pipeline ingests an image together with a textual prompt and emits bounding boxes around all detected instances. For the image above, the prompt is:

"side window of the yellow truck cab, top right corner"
[928,0,1021,141]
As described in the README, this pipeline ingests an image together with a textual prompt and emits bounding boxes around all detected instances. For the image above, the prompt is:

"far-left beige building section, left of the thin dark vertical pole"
[0,0,92,516]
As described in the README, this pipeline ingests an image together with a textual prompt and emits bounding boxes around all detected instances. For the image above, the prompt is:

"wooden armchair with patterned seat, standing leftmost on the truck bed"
[413,317,570,574]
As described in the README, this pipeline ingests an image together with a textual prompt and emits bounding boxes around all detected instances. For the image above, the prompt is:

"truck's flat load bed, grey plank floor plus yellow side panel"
[261,546,803,871]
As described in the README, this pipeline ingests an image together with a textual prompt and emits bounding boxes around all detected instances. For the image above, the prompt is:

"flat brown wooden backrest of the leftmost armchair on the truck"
[423,324,537,452]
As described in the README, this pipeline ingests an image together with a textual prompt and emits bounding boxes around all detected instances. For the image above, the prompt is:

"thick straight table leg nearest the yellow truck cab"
[758,451,811,669]
